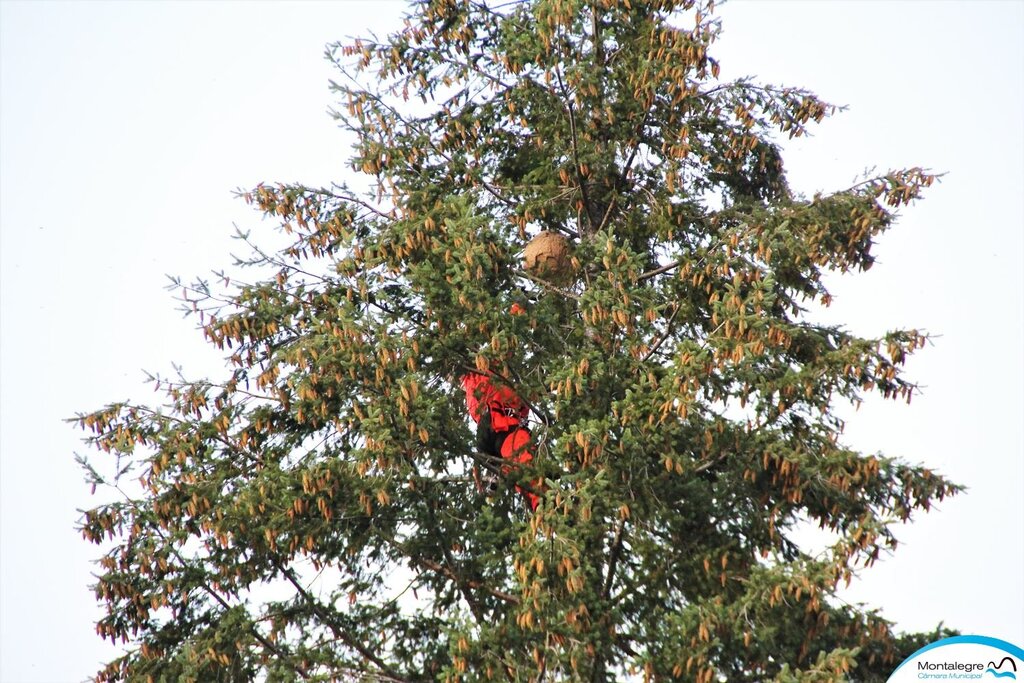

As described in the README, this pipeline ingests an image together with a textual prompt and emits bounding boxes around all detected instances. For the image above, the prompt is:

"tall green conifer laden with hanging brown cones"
[77,0,958,683]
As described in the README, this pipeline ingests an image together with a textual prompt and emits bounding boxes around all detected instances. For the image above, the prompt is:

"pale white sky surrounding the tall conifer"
[0,0,1024,683]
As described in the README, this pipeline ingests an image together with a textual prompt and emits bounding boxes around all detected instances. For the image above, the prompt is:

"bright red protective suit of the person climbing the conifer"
[462,373,540,510]
